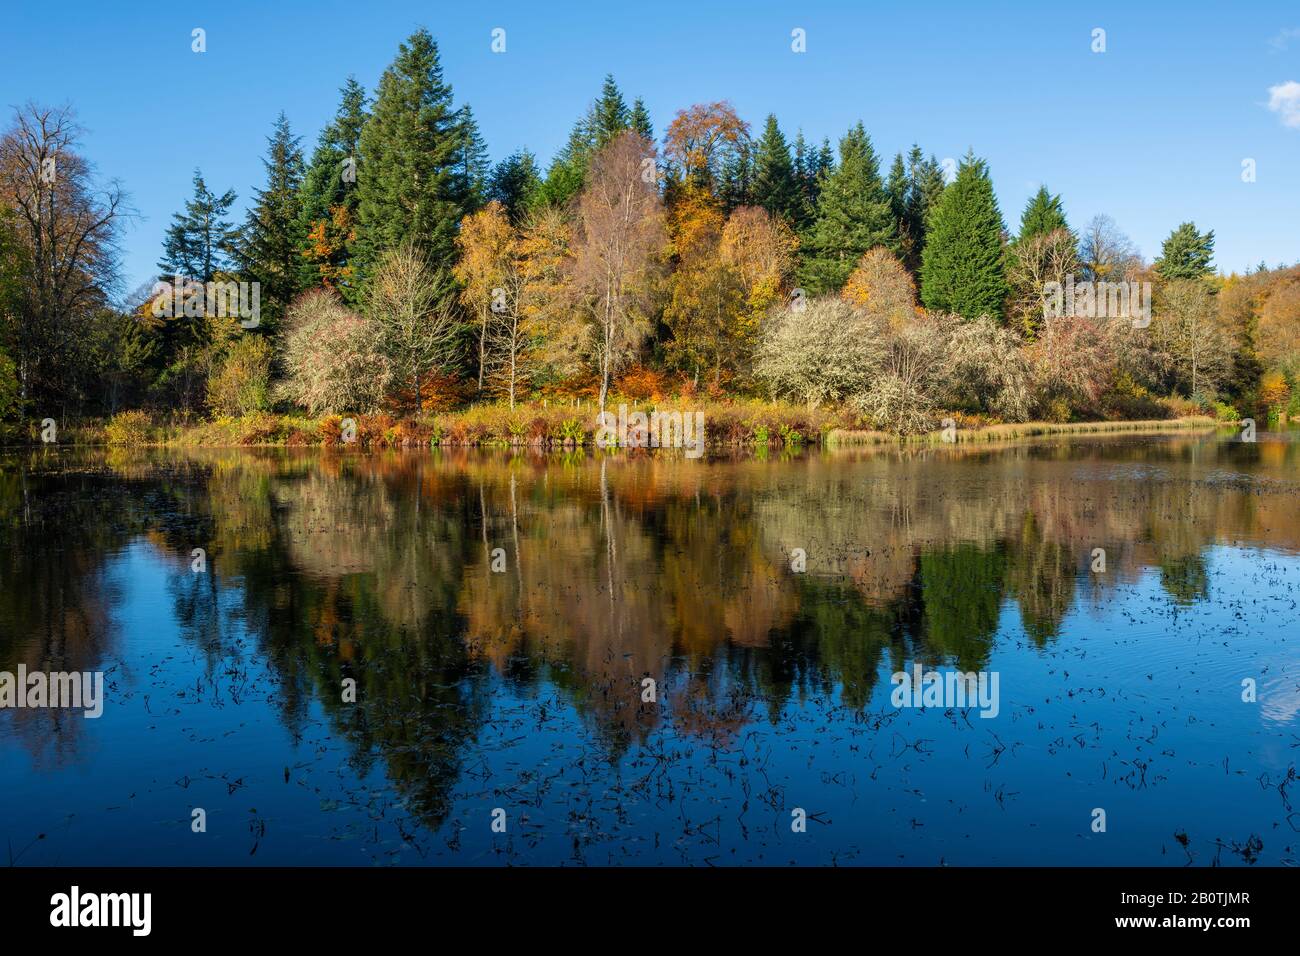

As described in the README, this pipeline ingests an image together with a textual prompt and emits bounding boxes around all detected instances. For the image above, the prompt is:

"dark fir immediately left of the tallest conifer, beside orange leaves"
[299,77,369,302]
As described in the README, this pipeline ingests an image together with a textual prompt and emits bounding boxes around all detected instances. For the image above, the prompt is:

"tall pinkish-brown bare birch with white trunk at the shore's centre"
[573,130,666,411]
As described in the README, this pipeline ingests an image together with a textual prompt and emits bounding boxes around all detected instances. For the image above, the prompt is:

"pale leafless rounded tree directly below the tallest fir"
[367,242,458,411]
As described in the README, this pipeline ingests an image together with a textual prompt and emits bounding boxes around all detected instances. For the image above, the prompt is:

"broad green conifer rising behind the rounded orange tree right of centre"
[803,122,898,294]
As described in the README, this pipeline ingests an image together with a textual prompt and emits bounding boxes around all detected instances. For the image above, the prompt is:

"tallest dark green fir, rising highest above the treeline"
[356,30,467,276]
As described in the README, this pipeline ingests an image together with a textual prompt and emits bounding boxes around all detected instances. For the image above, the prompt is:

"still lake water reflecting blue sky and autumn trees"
[0,433,1300,866]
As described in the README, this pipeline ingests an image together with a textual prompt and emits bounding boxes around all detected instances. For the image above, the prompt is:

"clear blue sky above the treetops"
[0,0,1300,287]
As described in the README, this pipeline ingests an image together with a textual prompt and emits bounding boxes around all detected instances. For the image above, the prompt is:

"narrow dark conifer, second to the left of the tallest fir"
[238,113,304,329]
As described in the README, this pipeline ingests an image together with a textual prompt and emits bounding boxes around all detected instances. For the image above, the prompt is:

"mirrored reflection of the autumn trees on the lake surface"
[0,437,1300,862]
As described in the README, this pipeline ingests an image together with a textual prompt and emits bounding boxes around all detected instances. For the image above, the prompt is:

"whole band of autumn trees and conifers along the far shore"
[0,30,1300,444]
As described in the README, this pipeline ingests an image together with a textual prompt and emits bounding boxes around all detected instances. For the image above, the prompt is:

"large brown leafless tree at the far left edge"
[0,103,130,399]
